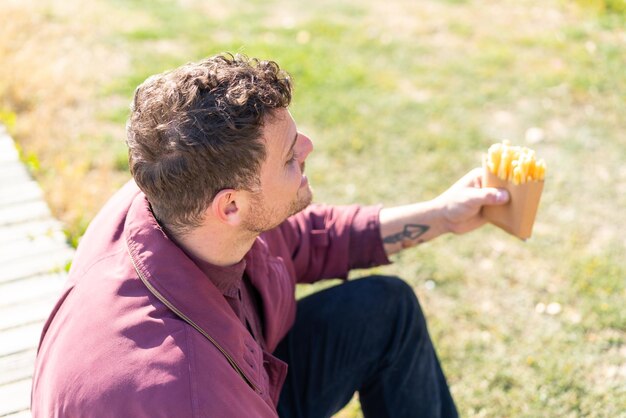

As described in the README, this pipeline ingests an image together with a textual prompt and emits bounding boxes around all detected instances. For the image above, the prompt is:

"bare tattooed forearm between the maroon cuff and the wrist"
[380,200,448,255]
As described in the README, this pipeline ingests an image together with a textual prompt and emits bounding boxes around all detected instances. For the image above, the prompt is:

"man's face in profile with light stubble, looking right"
[244,109,313,233]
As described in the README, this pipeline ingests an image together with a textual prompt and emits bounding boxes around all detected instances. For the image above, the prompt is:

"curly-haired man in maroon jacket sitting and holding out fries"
[32,55,508,418]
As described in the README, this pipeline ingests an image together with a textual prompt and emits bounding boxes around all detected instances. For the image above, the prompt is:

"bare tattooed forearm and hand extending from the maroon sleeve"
[380,168,509,255]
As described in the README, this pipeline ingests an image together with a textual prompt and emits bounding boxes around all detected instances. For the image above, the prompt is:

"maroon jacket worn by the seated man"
[32,182,387,418]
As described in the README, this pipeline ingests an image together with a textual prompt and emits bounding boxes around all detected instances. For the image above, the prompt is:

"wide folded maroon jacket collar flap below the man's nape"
[124,193,262,392]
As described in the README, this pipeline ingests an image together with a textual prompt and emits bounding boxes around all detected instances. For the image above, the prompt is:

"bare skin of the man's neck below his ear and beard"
[173,225,258,267]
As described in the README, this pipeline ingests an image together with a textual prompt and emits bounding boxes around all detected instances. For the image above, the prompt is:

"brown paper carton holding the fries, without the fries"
[482,164,544,240]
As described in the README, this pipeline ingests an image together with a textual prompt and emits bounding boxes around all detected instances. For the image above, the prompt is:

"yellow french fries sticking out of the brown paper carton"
[485,141,546,185]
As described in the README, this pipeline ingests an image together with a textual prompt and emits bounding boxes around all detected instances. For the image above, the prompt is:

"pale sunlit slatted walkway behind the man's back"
[0,125,74,418]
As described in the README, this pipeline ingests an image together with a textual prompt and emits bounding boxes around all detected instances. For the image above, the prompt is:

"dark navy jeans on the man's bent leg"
[274,276,458,418]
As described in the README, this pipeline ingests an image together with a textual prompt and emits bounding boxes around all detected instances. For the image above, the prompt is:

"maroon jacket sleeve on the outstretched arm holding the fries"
[280,205,389,283]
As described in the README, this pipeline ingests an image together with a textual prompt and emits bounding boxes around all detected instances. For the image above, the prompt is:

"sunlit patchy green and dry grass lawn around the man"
[0,0,626,418]
